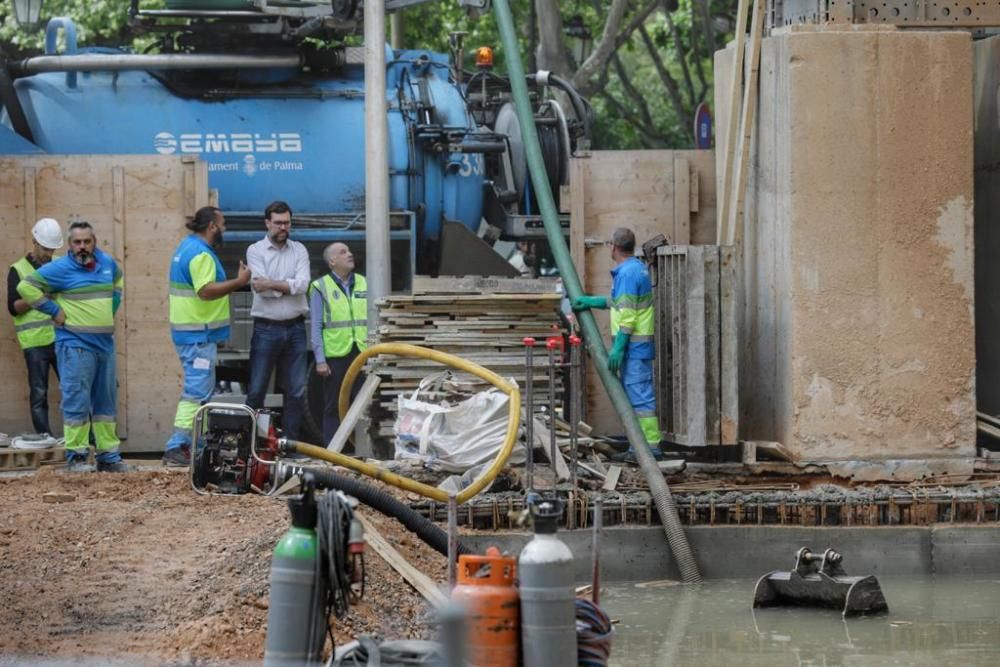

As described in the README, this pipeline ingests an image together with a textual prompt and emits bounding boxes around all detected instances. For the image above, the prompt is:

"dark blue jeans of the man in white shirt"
[247,319,309,440]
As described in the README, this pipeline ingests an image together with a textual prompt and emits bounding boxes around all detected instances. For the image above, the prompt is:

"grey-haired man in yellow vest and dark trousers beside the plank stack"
[309,243,368,446]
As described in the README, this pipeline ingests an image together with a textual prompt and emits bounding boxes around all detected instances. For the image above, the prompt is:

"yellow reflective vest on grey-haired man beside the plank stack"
[309,273,368,358]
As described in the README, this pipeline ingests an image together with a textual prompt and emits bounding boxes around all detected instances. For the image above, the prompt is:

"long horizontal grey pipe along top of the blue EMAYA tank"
[10,53,302,77]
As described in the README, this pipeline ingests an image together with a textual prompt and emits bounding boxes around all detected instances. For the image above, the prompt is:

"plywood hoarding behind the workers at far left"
[0,155,208,451]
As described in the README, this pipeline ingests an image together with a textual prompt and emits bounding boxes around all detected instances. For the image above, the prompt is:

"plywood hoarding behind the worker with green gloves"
[570,151,716,434]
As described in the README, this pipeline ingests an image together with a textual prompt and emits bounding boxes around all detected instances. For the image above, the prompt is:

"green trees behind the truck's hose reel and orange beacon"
[404,0,735,149]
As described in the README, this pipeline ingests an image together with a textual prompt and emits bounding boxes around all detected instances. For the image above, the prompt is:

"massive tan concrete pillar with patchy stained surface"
[715,27,975,460]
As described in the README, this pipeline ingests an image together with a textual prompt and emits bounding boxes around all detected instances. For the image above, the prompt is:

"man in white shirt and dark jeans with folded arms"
[247,201,309,440]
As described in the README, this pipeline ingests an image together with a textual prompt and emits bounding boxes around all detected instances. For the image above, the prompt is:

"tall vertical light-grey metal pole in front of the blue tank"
[365,0,392,336]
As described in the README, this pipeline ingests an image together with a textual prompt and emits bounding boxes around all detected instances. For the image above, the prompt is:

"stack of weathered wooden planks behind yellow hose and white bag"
[369,277,565,439]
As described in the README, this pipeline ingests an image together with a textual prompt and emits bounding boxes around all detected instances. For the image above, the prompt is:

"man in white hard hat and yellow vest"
[7,218,64,433]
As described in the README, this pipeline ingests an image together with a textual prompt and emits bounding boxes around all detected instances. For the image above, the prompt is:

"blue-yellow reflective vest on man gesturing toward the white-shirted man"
[170,234,229,345]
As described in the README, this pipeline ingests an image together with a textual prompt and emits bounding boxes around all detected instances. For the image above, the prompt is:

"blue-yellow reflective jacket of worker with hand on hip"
[17,249,124,352]
